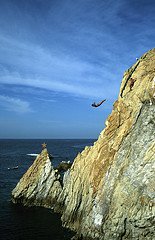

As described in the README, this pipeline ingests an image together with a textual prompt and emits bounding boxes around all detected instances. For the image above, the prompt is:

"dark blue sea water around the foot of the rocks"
[0,139,95,240]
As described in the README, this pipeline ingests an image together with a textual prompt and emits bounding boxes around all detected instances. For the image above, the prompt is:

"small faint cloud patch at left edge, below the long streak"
[0,95,31,113]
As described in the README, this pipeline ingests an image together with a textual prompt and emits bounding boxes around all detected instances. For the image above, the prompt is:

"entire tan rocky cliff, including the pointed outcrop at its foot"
[12,49,155,240]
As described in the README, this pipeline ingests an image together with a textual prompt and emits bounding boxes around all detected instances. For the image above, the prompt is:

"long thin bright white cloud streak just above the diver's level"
[0,74,116,98]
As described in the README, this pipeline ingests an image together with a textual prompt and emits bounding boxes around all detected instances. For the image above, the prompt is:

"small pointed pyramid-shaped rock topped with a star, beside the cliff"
[12,148,62,208]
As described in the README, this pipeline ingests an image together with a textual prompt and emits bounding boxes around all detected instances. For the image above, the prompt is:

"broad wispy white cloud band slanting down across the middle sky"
[0,33,118,97]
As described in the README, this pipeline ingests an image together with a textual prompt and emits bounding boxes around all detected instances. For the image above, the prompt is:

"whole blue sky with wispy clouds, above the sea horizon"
[0,0,155,139]
